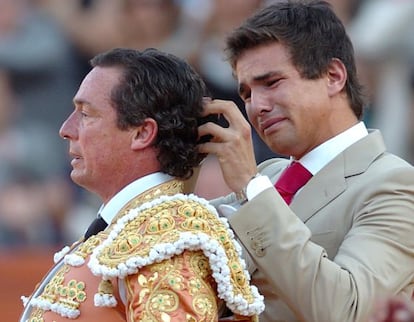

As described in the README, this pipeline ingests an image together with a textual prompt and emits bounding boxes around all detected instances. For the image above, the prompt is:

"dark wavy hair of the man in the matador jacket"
[90,48,208,179]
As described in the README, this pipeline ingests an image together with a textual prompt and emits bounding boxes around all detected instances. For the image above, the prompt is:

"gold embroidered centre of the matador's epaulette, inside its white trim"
[97,198,254,303]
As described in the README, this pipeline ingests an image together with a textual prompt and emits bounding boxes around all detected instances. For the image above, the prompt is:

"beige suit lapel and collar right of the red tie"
[290,130,385,222]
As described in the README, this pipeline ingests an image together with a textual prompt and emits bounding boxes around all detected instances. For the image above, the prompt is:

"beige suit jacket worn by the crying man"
[215,131,414,322]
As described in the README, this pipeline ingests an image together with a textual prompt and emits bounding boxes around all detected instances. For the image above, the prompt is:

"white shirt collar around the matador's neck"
[99,172,173,224]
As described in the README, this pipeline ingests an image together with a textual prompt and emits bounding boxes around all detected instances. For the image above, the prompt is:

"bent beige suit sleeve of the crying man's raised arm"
[230,167,414,322]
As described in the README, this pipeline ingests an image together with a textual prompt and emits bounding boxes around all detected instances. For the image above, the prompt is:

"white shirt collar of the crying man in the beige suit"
[299,122,368,175]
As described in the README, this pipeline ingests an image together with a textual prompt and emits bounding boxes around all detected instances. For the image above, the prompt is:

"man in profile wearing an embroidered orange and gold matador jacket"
[20,49,263,322]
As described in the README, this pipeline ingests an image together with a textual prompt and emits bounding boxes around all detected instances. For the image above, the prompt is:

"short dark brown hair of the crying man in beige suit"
[226,0,365,119]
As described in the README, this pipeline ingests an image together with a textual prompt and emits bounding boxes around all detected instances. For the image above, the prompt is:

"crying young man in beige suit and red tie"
[199,1,414,322]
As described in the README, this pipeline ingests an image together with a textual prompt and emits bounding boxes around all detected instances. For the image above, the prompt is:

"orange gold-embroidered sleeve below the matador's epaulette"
[125,251,218,322]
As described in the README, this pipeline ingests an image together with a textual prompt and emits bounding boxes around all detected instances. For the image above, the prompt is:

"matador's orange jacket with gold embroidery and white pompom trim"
[20,180,264,322]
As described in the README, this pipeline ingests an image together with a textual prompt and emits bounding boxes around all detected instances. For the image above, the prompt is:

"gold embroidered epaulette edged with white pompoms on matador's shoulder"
[88,194,264,316]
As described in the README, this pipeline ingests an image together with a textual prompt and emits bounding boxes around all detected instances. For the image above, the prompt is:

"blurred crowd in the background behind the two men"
[0,0,414,247]
